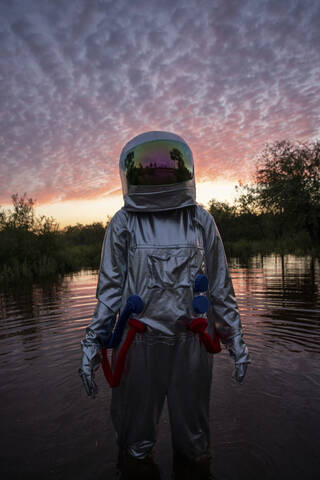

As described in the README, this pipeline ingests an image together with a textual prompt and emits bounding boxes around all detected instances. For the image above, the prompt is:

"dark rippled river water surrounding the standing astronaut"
[0,256,320,480]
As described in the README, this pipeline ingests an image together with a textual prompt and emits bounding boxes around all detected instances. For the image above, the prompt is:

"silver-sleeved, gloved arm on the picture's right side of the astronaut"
[205,210,249,383]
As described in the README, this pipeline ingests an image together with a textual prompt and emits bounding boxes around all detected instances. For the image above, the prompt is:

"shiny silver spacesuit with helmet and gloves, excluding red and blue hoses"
[80,132,249,459]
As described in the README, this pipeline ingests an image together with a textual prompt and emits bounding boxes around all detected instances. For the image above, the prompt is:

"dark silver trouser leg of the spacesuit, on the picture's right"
[168,335,212,459]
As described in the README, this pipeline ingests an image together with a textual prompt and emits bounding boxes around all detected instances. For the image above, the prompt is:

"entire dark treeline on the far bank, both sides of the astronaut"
[0,141,320,282]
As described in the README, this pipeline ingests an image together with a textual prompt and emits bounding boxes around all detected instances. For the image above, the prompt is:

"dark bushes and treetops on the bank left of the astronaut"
[0,194,109,282]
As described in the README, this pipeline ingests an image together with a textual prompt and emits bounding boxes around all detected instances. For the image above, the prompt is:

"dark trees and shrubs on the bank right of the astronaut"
[214,141,320,257]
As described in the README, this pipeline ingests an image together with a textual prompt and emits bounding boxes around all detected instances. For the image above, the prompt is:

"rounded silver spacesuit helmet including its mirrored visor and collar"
[120,131,196,211]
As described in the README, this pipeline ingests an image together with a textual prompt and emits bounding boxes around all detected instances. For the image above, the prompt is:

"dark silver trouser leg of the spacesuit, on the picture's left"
[111,341,175,458]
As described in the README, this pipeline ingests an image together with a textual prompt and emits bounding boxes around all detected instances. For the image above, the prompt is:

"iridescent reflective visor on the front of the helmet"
[124,140,193,185]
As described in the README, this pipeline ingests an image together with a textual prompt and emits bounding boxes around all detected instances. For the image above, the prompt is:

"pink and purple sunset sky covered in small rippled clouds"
[0,0,320,226]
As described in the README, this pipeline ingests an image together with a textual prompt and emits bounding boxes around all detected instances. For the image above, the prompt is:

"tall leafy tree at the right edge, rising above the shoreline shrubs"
[238,140,320,239]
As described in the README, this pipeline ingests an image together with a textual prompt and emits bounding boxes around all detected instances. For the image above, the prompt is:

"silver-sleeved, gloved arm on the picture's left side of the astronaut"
[79,210,127,397]
